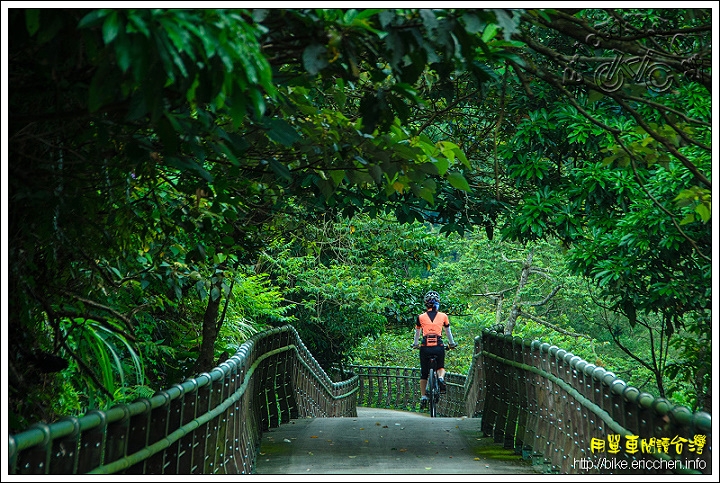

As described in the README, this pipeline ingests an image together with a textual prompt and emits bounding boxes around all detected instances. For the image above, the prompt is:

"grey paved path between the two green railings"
[255,408,541,479]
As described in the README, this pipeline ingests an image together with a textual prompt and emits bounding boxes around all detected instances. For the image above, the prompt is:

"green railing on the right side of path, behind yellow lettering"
[467,330,712,474]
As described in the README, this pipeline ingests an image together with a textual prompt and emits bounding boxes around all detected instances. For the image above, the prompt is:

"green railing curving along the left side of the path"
[9,326,357,474]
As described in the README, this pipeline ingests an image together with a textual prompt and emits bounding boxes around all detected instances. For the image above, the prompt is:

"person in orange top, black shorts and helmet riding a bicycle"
[413,290,457,408]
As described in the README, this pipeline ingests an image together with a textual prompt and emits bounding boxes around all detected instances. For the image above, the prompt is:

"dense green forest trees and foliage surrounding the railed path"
[2,7,714,431]
